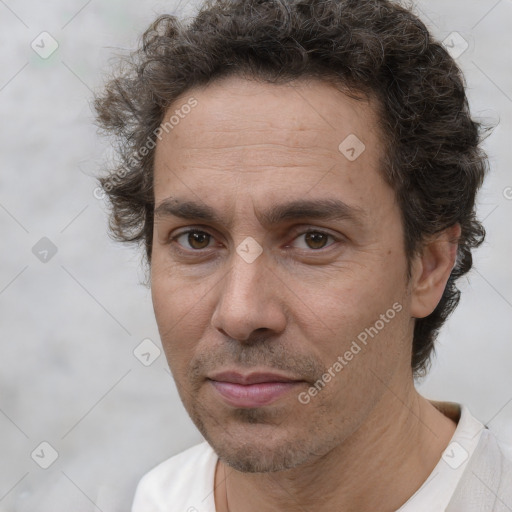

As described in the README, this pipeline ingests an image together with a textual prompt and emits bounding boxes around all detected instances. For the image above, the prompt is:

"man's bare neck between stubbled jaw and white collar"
[216,383,456,512]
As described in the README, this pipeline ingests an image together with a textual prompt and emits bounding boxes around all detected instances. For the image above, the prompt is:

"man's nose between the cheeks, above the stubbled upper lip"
[211,246,286,342]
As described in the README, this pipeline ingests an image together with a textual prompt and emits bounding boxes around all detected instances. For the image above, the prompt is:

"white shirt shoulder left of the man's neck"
[132,441,218,512]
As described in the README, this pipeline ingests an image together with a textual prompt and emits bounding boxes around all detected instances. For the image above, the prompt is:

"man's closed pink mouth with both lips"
[208,372,305,407]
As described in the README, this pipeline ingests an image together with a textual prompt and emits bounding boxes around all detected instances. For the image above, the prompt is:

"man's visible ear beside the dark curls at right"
[411,224,461,318]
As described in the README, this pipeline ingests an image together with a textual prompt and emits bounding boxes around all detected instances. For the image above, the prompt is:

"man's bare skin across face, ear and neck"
[151,77,460,512]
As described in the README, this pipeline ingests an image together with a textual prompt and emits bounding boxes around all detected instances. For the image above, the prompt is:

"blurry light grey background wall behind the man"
[0,0,512,512]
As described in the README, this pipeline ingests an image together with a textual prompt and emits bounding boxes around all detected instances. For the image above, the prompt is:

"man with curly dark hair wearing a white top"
[96,0,512,512]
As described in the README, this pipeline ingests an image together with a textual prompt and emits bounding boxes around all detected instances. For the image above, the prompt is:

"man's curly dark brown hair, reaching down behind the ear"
[94,0,490,378]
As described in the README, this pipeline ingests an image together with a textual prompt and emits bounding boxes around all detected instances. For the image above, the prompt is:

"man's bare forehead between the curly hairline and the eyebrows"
[154,77,386,222]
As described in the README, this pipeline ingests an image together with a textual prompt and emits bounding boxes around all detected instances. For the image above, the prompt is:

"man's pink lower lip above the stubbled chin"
[210,380,302,407]
